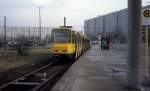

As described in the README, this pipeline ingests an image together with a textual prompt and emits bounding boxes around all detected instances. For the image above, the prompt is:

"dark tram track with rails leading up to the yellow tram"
[0,61,71,91]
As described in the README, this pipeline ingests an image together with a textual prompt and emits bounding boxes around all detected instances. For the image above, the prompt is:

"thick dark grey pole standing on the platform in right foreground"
[127,0,142,90]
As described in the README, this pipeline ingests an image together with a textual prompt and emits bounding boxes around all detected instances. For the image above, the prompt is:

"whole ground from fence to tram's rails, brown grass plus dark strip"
[0,49,51,85]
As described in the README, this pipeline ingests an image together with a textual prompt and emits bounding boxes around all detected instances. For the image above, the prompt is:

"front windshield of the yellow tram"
[53,31,70,43]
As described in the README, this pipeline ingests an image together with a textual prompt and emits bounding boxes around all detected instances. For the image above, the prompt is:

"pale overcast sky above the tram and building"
[0,0,150,27]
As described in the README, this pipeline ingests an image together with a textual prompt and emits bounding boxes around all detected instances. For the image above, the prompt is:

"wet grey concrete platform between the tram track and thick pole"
[51,46,126,91]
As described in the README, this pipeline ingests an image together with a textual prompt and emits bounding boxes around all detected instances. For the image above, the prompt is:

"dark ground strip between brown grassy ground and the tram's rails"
[0,60,51,87]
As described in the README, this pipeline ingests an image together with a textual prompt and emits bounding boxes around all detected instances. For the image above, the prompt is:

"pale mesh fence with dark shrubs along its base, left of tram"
[0,26,53,49]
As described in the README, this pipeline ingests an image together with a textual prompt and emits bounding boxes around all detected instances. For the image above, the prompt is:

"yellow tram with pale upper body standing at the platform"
[51,26,89,59]
